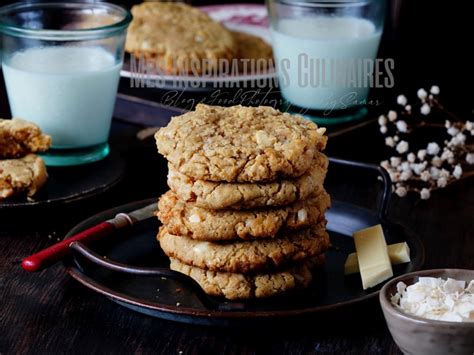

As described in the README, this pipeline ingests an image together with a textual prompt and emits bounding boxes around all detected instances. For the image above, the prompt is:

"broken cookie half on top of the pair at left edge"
[0,118,51,159]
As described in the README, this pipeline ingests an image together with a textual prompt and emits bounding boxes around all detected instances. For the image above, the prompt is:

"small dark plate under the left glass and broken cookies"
[0,153,125,212]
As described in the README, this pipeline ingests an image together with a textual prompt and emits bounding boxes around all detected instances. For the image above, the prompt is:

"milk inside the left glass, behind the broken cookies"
[3,47,122,148]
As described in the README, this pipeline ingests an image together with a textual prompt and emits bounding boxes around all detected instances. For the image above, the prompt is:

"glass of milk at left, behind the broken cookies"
[0,2,131,166]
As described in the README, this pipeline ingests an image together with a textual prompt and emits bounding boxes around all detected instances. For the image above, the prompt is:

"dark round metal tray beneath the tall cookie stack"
[66,160,424,325]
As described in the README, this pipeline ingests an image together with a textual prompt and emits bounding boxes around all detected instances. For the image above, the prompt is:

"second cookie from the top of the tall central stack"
[168,153,328,210]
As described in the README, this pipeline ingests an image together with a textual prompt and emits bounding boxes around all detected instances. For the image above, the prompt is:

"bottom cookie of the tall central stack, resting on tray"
[170,256,324,300]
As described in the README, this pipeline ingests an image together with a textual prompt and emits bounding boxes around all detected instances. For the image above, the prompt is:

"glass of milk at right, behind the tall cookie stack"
[267,0,385,124]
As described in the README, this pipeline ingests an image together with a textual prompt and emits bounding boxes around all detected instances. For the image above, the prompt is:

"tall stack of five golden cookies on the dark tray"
[155,105,330,299]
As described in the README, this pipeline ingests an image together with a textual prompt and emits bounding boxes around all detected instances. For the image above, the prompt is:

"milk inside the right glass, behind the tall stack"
[272,16,381,110]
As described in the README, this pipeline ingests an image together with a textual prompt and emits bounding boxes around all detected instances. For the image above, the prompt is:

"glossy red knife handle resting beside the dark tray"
[21,221,115,272]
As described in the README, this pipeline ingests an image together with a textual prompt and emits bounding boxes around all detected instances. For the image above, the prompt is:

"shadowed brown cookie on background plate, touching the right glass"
[232,31,273,75]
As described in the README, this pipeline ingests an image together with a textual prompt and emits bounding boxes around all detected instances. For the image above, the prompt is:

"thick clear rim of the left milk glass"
[0,1,133,41]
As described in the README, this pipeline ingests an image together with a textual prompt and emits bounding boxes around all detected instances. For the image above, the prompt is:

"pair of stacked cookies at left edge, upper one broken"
[0,118,51,201]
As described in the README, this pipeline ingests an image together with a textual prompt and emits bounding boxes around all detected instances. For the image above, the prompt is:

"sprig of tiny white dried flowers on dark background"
[378,86,474,200]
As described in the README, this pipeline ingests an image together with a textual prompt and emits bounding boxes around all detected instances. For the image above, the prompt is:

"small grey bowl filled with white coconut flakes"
[379,269,474,355]
